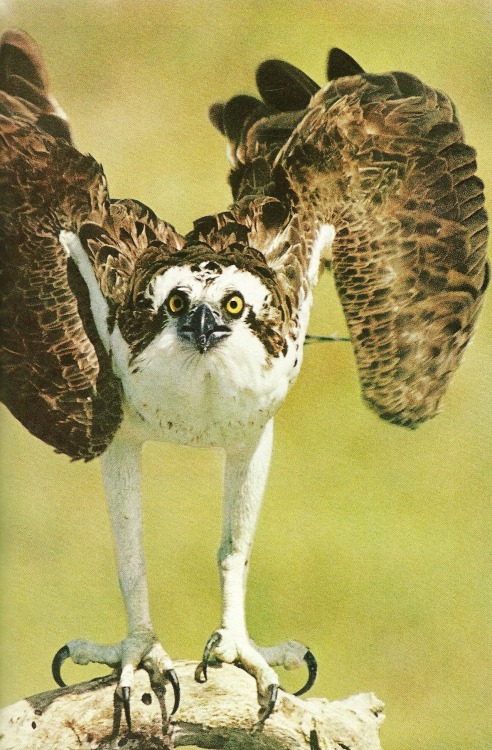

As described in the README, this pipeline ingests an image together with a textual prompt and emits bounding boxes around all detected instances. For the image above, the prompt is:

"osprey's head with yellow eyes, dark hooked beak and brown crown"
[118,236,289,372]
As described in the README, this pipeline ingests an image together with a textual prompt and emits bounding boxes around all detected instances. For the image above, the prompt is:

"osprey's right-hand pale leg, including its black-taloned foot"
[195,420,316,721]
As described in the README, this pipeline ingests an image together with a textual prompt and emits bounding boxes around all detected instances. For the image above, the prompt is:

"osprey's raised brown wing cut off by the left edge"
[0,32,181,460]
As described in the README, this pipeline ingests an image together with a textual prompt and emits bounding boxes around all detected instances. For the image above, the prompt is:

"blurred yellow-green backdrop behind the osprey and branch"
[0,0,492,750]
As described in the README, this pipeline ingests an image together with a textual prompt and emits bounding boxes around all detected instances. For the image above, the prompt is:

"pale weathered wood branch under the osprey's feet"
[0,661,384,750]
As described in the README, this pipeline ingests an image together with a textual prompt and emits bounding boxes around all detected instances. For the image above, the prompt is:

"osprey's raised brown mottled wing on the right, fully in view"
[212,50,488,426]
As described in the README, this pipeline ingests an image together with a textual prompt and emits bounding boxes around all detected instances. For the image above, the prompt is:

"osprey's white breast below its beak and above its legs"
[111,325,300,449]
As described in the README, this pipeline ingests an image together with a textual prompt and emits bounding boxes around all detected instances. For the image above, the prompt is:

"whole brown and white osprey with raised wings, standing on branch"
[0,31,488,724]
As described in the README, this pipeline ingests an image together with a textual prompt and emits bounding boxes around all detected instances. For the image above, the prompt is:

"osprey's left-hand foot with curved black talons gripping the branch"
[52,628,180,731]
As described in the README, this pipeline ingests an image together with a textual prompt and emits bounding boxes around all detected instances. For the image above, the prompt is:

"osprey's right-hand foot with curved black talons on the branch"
[195,628,317,723]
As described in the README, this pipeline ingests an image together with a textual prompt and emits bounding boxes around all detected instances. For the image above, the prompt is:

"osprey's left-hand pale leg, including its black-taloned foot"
[53,436,179,726]
